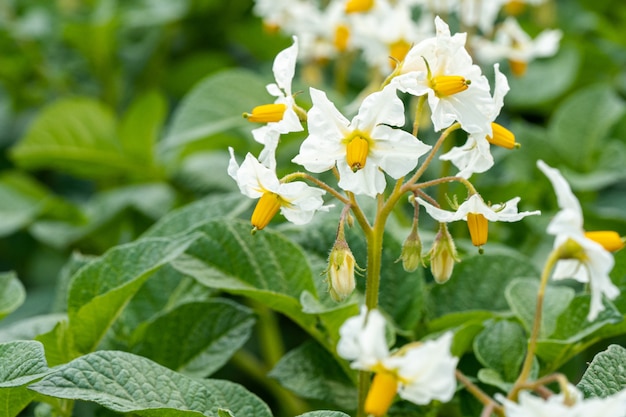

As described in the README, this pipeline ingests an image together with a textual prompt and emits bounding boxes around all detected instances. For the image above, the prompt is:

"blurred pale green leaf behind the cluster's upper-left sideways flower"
[160,69,266,155]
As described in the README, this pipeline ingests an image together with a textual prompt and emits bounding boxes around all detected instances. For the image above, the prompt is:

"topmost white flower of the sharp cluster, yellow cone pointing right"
[390,17,493,134]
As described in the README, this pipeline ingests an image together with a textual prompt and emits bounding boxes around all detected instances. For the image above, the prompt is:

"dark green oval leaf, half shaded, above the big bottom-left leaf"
[133,300,255,378]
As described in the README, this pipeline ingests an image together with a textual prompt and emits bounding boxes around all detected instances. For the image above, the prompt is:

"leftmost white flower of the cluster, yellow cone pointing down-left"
[228,148,328,230]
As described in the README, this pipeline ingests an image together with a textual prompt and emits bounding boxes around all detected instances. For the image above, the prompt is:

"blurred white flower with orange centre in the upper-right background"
[472,17,563,76]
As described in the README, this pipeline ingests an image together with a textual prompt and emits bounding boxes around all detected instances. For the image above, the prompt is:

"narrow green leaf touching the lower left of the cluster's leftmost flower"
[143,192,252,237]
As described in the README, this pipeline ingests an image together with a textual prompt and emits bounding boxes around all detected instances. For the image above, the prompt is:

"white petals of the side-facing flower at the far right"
[537,160,619,321]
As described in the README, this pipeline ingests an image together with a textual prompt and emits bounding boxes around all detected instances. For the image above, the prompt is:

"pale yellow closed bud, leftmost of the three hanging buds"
[326,239,356,302]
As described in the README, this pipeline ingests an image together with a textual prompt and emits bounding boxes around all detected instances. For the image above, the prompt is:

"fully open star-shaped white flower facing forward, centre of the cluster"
[293,88,430,197]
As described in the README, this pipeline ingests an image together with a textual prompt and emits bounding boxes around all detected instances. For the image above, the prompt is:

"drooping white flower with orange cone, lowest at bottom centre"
[337,307,458,417]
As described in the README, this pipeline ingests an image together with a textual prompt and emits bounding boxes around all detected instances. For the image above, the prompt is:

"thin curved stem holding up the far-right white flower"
[508,249,562,401]
